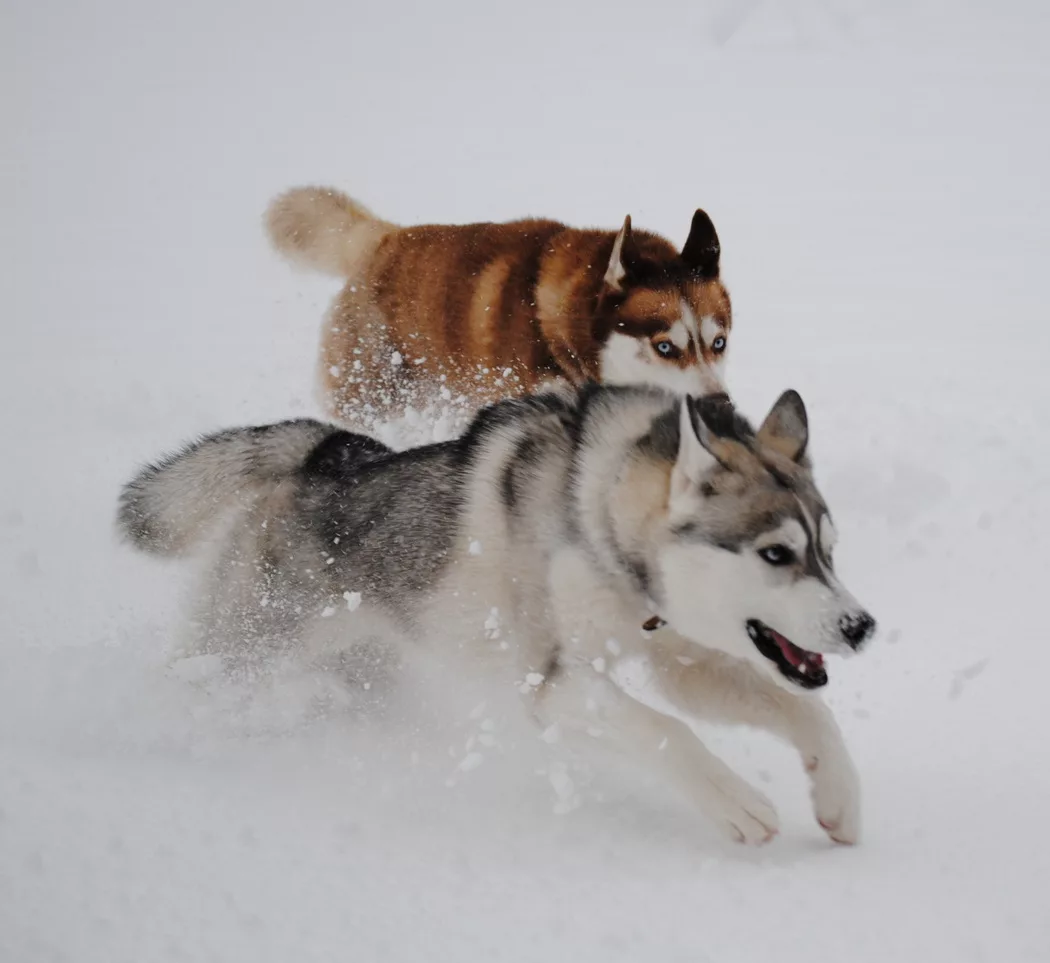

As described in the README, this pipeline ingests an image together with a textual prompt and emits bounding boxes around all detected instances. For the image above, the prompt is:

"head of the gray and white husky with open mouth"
[657,392,875,689]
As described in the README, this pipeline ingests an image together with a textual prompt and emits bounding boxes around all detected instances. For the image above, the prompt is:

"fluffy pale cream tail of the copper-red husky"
[266,187,396,278]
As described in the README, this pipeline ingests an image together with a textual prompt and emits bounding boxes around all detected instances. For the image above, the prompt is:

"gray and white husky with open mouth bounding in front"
[119,386,875,843]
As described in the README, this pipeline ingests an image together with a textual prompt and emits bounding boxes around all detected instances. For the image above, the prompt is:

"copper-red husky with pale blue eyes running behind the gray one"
[267,187,732,420]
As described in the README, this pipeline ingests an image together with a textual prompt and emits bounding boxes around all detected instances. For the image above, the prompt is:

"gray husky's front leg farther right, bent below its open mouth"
[651,643,861,843]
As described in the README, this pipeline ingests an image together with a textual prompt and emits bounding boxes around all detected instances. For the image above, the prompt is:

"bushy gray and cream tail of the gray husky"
[117,419,339,556]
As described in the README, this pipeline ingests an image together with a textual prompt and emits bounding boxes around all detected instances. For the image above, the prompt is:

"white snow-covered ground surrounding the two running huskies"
[6,0,1050,963]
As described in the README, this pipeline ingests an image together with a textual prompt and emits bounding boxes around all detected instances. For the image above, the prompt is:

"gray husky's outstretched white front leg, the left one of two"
[538,667,779,844]
